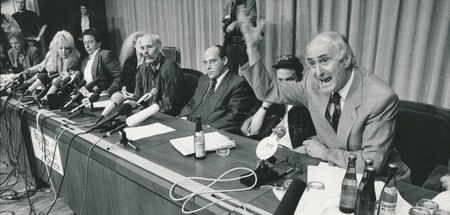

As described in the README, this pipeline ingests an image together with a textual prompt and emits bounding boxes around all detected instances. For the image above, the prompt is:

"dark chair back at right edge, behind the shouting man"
[393,101,450,186]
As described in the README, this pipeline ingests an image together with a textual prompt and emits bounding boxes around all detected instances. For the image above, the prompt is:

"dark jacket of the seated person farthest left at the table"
[8,46,42,72]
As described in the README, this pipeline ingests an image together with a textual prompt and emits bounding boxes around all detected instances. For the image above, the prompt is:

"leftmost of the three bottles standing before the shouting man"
[339,154,357,213]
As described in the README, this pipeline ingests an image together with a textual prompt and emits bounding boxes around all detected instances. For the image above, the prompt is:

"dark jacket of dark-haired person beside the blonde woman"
[81,49,122,95]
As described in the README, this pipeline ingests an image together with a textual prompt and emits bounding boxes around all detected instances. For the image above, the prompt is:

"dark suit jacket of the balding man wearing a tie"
[180,72,256,133]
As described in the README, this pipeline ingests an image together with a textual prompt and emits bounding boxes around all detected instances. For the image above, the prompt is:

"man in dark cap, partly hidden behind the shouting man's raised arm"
[241,55,316,150]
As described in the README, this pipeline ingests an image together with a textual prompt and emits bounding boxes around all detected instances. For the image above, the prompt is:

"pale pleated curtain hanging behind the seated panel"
[105,0,450,108]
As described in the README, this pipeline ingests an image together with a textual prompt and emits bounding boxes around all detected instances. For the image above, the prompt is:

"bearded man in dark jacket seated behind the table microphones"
[122,34,184,116]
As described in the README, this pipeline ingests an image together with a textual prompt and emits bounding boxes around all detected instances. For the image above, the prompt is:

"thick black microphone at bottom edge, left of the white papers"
[273,178,306,215]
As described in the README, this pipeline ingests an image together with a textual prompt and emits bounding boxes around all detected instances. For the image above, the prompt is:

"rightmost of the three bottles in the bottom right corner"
[378,163,397,215]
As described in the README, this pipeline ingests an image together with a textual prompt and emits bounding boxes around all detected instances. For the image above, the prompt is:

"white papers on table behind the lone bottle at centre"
[170,131,236,156]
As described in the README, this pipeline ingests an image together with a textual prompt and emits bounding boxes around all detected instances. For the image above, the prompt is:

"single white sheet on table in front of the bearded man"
[124,122,175,140]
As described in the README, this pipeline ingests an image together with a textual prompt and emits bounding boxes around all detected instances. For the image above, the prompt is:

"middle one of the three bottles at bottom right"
[355,167,377,215]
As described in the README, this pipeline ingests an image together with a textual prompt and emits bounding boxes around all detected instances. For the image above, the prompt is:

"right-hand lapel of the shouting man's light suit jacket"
[337,69,363,146]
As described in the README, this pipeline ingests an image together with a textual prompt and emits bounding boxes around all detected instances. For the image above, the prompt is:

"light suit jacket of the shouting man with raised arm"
[244,62,408,174]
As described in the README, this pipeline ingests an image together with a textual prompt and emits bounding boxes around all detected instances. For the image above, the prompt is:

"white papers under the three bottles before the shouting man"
[295,163,411,215]
